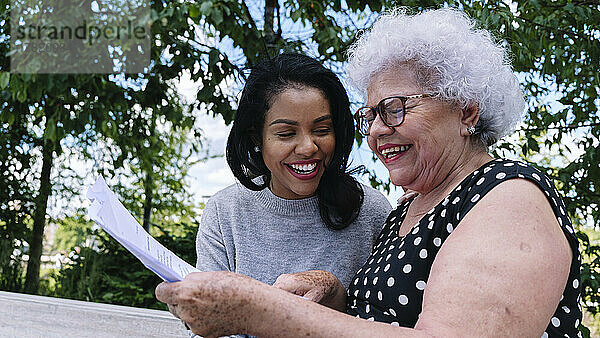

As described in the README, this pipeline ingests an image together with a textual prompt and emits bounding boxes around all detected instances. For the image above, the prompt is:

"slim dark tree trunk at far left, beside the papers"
[24,132,54,293]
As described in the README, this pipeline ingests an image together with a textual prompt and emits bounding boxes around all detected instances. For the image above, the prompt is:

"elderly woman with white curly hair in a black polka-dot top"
[156,9,581,337]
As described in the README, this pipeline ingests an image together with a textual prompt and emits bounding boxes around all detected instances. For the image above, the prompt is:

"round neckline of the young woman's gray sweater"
[253,188,319,216]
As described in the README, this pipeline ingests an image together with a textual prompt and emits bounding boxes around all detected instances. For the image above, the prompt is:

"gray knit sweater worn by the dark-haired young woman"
[196,183,391,286]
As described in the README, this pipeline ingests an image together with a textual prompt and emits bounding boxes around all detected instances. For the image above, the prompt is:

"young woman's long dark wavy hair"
[226,53,364,229]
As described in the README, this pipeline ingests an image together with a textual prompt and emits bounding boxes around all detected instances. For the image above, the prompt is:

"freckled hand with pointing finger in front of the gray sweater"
[273,270,346,312]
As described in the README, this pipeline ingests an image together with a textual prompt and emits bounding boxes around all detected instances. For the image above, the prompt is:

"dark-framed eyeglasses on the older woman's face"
[354,94,433,136]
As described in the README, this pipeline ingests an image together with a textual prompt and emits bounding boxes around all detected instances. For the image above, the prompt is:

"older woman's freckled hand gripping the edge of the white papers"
[156,271,266,337]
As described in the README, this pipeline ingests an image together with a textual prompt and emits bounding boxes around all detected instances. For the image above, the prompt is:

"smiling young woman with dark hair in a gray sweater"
[197,54,391,285]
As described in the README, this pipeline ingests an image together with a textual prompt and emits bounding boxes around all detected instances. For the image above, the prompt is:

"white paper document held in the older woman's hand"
[87,177,199,282]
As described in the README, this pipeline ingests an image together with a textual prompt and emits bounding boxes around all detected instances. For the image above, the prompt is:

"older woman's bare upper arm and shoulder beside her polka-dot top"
[420,178,572,336]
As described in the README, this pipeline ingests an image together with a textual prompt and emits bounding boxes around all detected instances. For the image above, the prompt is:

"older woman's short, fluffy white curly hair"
[347,8,525,146]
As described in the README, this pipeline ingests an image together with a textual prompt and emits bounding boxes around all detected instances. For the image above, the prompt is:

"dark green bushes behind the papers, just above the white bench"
[54,223,197,310]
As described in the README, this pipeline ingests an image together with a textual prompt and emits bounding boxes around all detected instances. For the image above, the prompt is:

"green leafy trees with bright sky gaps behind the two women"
[0,0,600,336]
